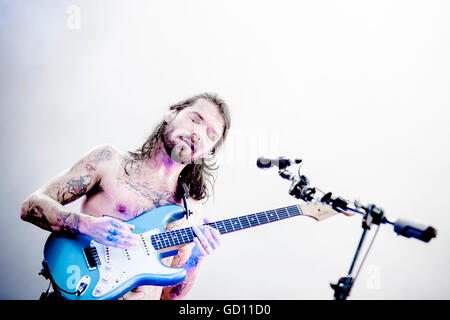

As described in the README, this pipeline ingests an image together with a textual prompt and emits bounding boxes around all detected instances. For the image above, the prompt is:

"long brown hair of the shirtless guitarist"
[125,92,231,201]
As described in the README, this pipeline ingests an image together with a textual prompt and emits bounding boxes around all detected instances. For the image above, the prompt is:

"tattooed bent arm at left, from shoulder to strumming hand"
[20,144,139,248]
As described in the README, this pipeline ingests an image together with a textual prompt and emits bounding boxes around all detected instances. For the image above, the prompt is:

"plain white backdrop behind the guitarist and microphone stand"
[0,0,450,299]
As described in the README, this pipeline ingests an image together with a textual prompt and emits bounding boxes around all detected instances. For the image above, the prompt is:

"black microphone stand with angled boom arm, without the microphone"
[262,157,437,300]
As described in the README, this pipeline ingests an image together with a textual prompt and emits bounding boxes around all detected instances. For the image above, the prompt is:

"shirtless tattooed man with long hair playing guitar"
[21,93,230,299]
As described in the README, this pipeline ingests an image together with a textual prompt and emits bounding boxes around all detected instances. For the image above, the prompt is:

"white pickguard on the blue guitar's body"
[91,229,176,297]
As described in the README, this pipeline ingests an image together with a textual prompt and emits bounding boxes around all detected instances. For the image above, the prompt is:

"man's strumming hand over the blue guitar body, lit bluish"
[80,216,139,249]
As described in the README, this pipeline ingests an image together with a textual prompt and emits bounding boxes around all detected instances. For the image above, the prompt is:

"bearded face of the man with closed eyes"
[163,99,225,163]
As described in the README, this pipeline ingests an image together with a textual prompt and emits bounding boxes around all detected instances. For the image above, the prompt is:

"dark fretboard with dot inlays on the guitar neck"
[150,205,302,250]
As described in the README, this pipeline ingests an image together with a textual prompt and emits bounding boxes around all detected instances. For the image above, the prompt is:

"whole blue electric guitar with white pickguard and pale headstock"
[43,201,348,300]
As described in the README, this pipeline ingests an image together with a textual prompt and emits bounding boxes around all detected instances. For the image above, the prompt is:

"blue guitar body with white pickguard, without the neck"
[44,205,186,300]
